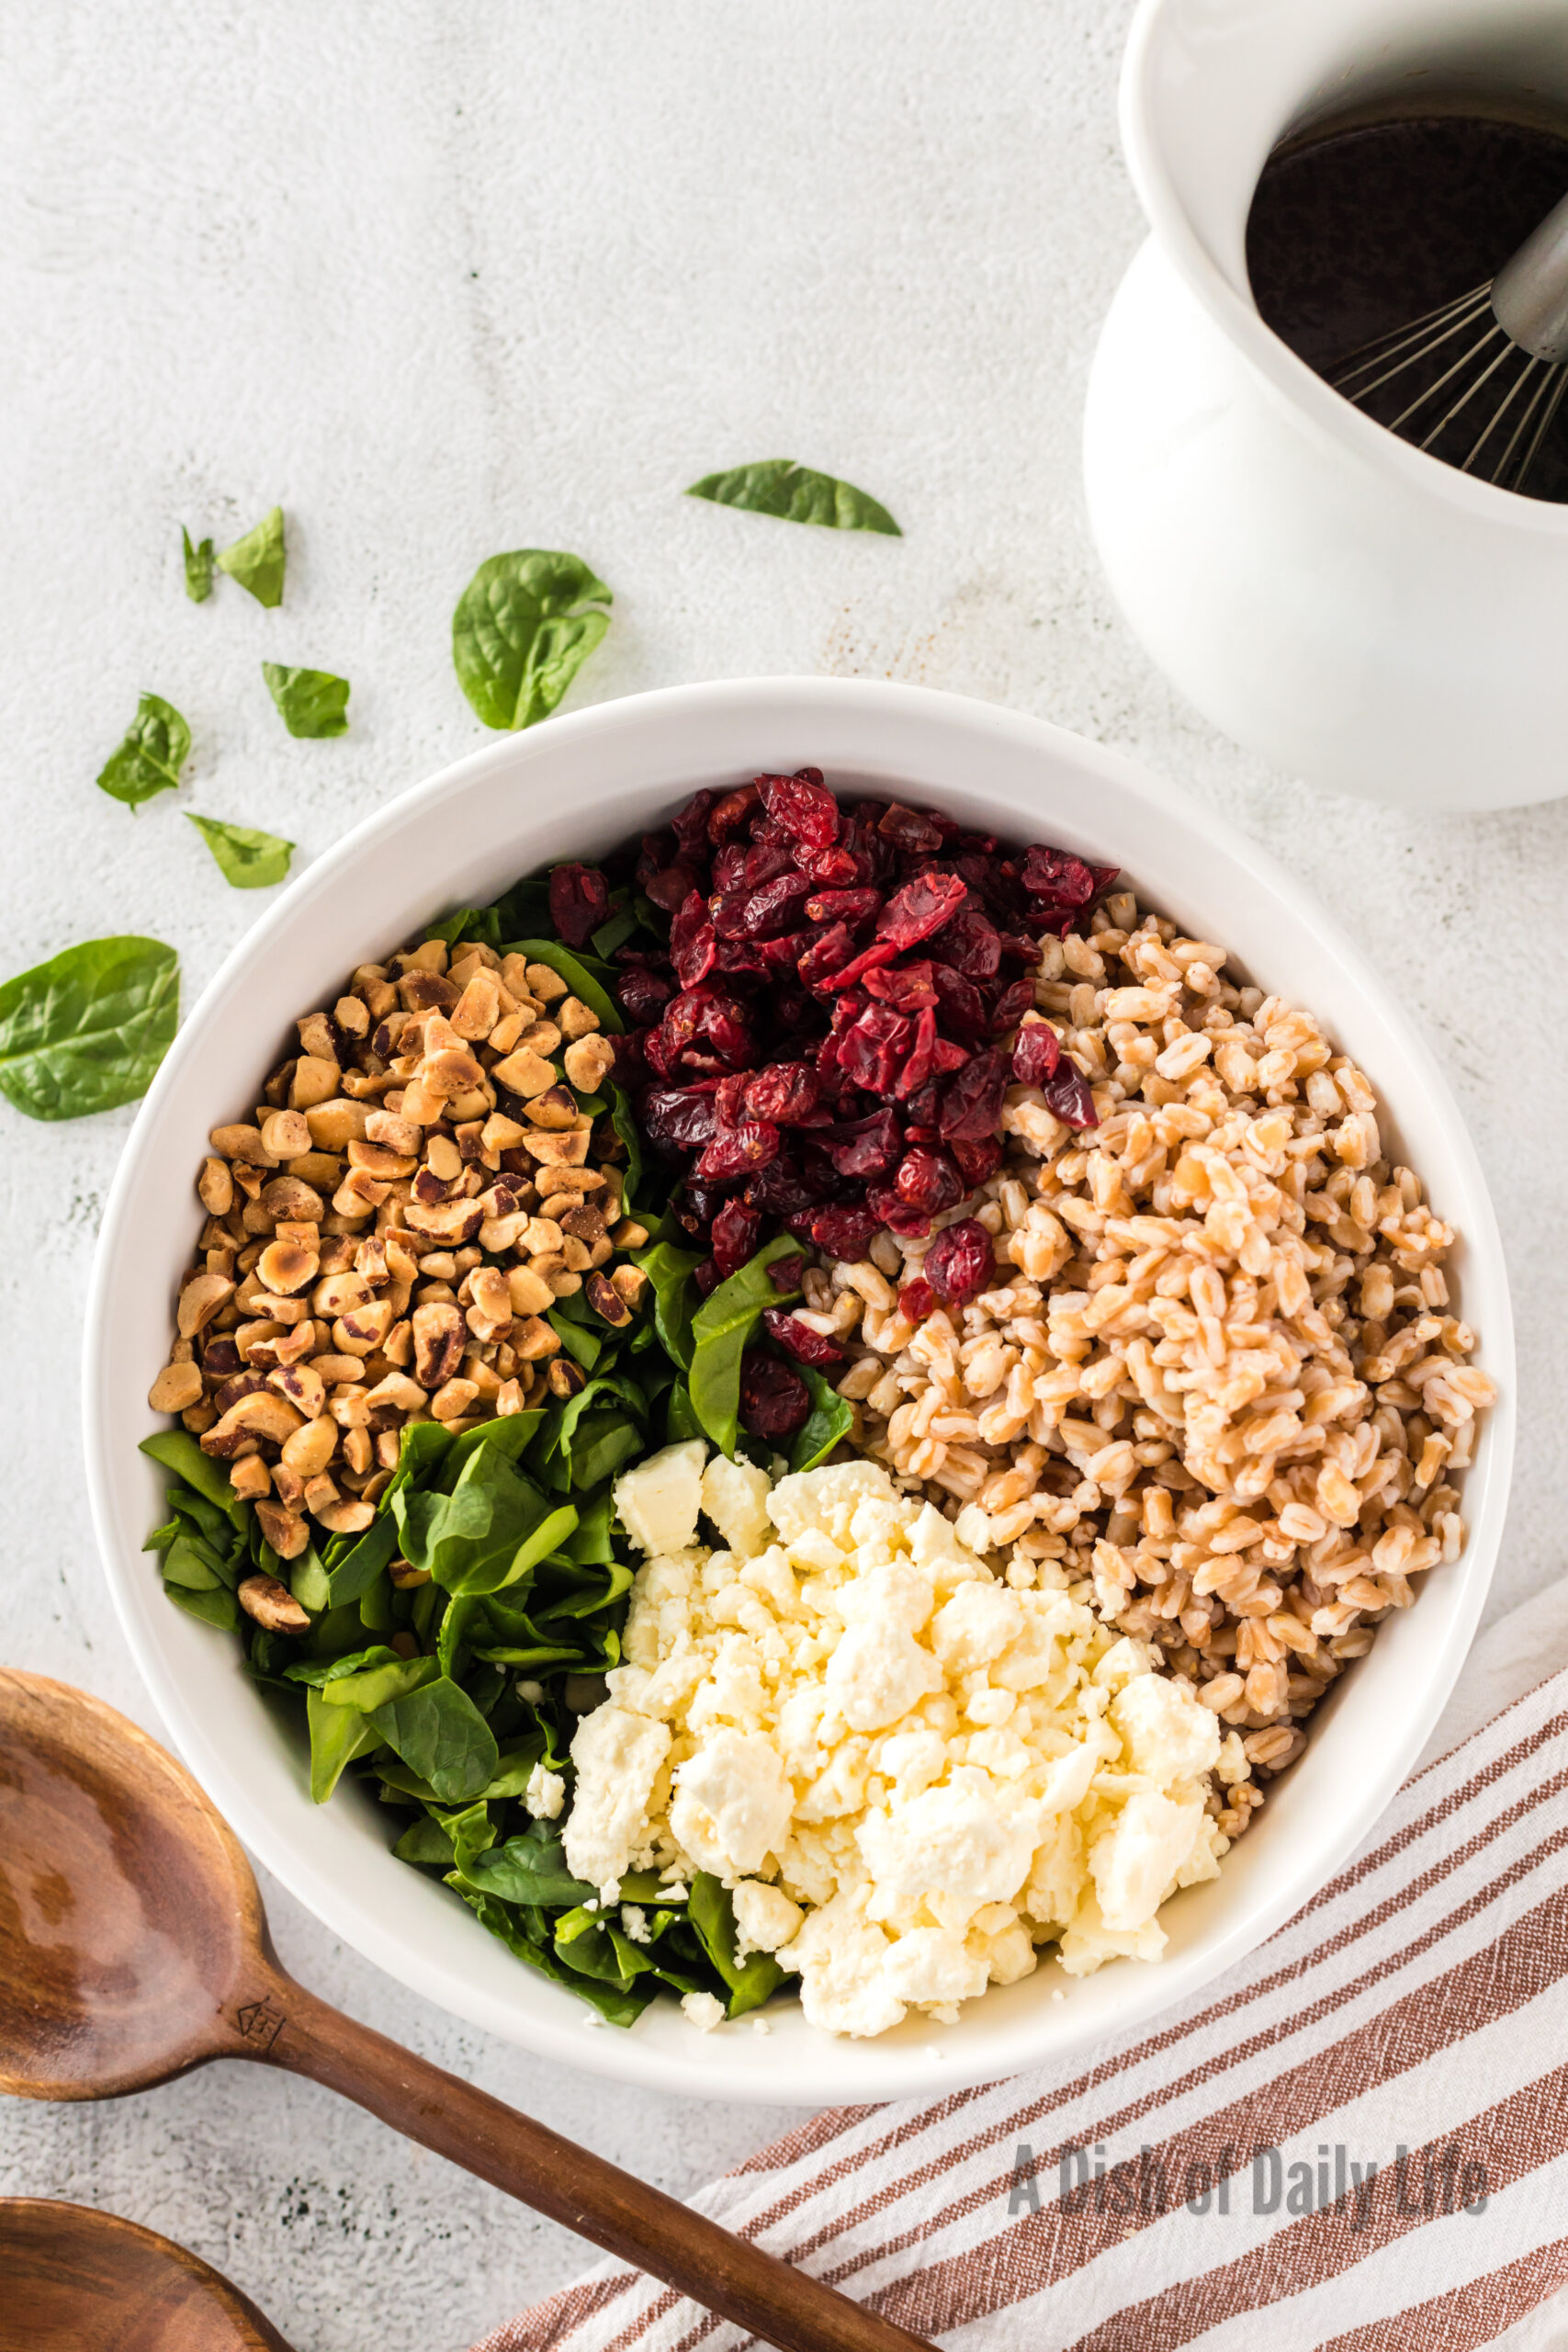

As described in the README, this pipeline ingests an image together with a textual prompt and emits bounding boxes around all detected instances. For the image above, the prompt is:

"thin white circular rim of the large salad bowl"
[83,677,1517,2105]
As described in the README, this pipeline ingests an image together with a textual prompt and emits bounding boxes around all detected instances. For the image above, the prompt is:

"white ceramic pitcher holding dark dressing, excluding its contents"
[1084,0,1568,809]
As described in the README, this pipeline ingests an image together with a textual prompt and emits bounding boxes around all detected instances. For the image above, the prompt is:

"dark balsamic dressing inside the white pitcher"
[1246,113,1568,503]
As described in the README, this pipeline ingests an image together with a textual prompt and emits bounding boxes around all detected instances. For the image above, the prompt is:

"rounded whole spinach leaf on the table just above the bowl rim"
[451,548,611,727]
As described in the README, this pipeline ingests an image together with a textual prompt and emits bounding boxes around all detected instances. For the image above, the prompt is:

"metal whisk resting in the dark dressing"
[1328,195,1568,489]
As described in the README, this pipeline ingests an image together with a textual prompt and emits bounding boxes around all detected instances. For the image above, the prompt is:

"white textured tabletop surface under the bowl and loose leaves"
[0,0,1568,2352]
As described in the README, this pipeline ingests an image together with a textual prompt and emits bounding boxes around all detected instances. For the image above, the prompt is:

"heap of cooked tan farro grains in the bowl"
[804,891,1495,1837]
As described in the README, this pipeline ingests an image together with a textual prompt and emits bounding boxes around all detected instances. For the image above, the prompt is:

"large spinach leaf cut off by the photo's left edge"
[0,938,179,1124]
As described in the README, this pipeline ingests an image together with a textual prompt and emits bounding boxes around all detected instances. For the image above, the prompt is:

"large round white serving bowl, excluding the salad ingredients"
[85,677,1514,2105]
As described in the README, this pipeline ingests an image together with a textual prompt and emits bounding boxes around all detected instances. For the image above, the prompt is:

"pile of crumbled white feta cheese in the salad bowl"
[564,1440,1229,2034]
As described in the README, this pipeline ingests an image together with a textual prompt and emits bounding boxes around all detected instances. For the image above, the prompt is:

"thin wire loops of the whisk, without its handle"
[1328,277,1568,489]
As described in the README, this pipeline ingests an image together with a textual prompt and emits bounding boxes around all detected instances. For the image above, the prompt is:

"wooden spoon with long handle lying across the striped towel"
[0,1670,931,2352]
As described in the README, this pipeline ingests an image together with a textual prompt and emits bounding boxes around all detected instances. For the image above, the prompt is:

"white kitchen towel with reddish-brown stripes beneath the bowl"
[478,1588,1568,2352]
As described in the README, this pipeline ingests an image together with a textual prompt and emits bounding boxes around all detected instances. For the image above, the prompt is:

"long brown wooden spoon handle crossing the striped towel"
[254,1975,931,2352]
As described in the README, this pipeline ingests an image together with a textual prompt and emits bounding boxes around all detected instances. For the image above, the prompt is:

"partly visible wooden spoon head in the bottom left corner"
[0,2197,289,2352]
